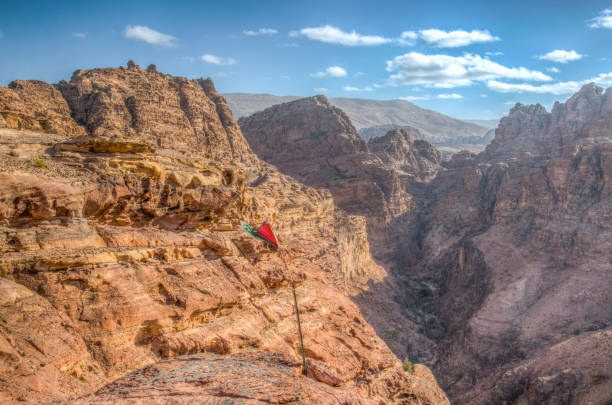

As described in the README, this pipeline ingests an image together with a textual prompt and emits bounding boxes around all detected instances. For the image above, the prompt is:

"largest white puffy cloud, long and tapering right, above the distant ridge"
[386,52,552,88]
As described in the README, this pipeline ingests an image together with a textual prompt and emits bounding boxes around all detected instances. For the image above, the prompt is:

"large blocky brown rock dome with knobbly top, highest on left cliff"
[58,63,252,161]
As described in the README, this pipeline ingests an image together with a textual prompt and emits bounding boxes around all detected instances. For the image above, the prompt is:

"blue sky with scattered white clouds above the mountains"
[0,0,612,119]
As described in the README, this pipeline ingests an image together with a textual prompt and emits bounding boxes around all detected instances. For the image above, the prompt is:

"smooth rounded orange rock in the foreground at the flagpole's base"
[61,351,445,405]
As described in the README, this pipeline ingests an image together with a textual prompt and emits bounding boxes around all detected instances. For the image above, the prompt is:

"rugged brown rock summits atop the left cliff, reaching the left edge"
[0,59,254,163]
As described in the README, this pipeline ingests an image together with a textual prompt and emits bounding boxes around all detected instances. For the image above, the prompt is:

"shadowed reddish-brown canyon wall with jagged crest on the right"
[405,85,612,404]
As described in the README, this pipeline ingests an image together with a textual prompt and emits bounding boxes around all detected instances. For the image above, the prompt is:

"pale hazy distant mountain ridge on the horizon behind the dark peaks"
[223,93,492,152]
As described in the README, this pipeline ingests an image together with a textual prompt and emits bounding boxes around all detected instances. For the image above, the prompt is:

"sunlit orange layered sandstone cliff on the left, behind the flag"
[0,63,448,404]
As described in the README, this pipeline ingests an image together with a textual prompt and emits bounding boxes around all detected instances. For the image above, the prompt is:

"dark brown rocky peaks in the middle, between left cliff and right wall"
[238,96,440,246]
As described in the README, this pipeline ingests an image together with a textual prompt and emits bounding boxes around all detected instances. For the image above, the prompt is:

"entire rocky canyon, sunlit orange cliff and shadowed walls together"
[0,61,612,405]
